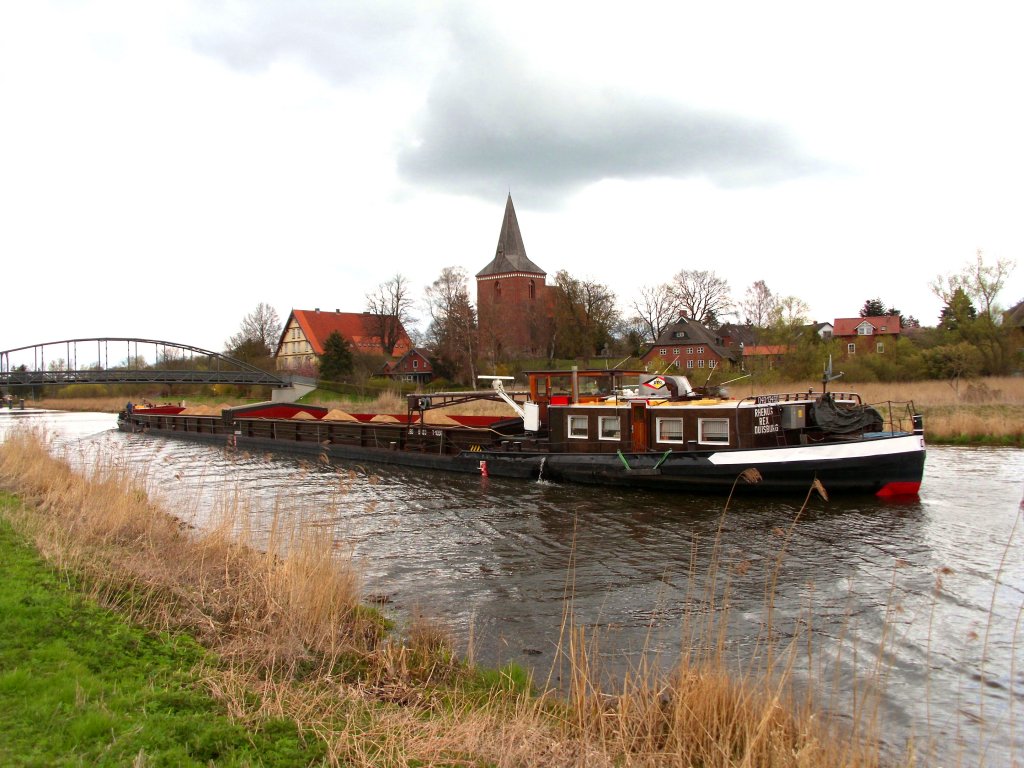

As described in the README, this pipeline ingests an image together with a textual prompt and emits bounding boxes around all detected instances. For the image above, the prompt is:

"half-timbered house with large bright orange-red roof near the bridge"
[274,308,413,371]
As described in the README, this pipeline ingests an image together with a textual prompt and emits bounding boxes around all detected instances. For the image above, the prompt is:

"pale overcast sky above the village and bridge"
[0,0,1024,358]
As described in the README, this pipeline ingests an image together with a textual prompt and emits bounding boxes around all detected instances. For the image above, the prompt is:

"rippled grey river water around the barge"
[0,411,1024,766]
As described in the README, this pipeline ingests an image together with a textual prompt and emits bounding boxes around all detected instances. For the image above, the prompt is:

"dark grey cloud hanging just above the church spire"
[398,70,821,204]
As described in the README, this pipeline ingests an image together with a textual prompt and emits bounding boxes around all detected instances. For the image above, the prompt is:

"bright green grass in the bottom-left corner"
[0,494,323,766]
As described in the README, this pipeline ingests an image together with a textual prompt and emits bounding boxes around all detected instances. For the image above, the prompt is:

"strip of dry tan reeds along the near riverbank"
[0,432,913,768]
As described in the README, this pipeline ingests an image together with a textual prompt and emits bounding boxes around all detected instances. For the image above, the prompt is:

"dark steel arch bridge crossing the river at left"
[0,337,299,388]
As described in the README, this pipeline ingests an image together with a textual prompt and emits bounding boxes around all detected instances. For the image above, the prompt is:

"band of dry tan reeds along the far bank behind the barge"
[18,376,1024,447]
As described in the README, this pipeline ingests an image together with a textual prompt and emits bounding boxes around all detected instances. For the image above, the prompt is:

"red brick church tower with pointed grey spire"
[476,195,550,359]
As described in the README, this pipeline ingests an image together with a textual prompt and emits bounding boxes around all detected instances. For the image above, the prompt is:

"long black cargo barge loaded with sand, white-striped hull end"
[119,370,925,497]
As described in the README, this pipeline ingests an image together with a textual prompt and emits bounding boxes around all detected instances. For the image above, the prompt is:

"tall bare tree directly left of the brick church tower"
[425,266,476,384]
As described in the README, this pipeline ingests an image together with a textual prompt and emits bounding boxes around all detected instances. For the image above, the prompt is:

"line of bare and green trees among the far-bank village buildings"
[225,250,1022,384]
